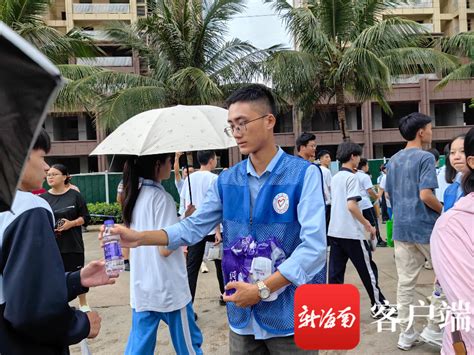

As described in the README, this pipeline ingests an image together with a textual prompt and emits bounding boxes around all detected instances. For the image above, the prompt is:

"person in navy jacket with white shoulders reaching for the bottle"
[0,129,118,355]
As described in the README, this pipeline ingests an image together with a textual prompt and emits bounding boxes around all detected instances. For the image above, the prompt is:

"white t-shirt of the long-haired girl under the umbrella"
[130,180,191,312]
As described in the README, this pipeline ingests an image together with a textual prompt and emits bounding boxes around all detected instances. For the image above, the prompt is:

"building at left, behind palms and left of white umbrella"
[44,0,147,173]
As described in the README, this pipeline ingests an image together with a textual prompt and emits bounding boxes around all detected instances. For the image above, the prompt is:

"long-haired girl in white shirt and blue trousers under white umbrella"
[122,154,203,354]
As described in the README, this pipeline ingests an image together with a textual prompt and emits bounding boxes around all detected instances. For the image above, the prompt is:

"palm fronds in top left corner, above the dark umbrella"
[0,0,99,64]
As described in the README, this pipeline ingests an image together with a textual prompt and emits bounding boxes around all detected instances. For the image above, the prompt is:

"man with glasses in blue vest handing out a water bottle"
[109,85,326,354]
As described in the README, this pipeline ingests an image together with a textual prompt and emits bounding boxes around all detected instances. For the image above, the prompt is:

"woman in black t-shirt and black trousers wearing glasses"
[41,164,91,312]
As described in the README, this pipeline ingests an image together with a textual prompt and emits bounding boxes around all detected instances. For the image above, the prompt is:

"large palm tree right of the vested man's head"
[266,0,458,140]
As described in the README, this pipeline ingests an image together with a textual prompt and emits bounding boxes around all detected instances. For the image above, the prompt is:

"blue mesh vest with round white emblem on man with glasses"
[218,153,326,334]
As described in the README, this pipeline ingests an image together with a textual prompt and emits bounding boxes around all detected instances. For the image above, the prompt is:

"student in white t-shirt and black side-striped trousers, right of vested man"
[328,142,393,318]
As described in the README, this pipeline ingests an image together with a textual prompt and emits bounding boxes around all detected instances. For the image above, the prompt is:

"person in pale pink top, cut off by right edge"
[431,128,474,355]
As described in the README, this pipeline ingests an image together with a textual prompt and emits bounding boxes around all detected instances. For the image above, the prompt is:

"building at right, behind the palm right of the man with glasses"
[230,0,474,163]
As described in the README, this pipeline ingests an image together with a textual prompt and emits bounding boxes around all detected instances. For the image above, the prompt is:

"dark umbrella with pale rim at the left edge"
[0,22,61,212]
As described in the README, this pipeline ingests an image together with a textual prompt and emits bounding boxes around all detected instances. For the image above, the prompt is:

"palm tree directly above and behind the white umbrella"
[58,0,278,130]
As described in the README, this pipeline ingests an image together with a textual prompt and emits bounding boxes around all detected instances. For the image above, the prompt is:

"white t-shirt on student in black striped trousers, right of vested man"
[328,168,365,240]
